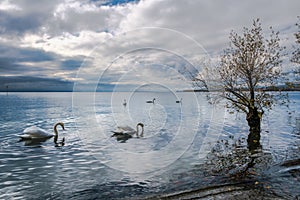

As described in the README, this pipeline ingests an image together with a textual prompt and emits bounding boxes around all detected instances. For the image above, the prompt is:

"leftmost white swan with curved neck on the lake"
[20,122,65,140]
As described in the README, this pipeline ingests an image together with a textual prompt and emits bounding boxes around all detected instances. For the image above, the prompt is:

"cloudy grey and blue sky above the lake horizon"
[0,0,300,91]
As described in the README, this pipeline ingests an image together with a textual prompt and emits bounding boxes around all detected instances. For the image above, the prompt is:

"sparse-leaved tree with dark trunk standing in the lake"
[216,19,284,148]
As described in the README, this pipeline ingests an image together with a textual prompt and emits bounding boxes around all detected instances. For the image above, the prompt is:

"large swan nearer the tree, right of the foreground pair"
[111,123,144,142]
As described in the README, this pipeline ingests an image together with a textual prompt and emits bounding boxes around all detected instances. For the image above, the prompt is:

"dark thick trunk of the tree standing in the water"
[246,107,261,151]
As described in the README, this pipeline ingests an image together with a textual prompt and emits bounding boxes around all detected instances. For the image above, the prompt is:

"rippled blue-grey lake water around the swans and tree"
[0,92,300,199]
